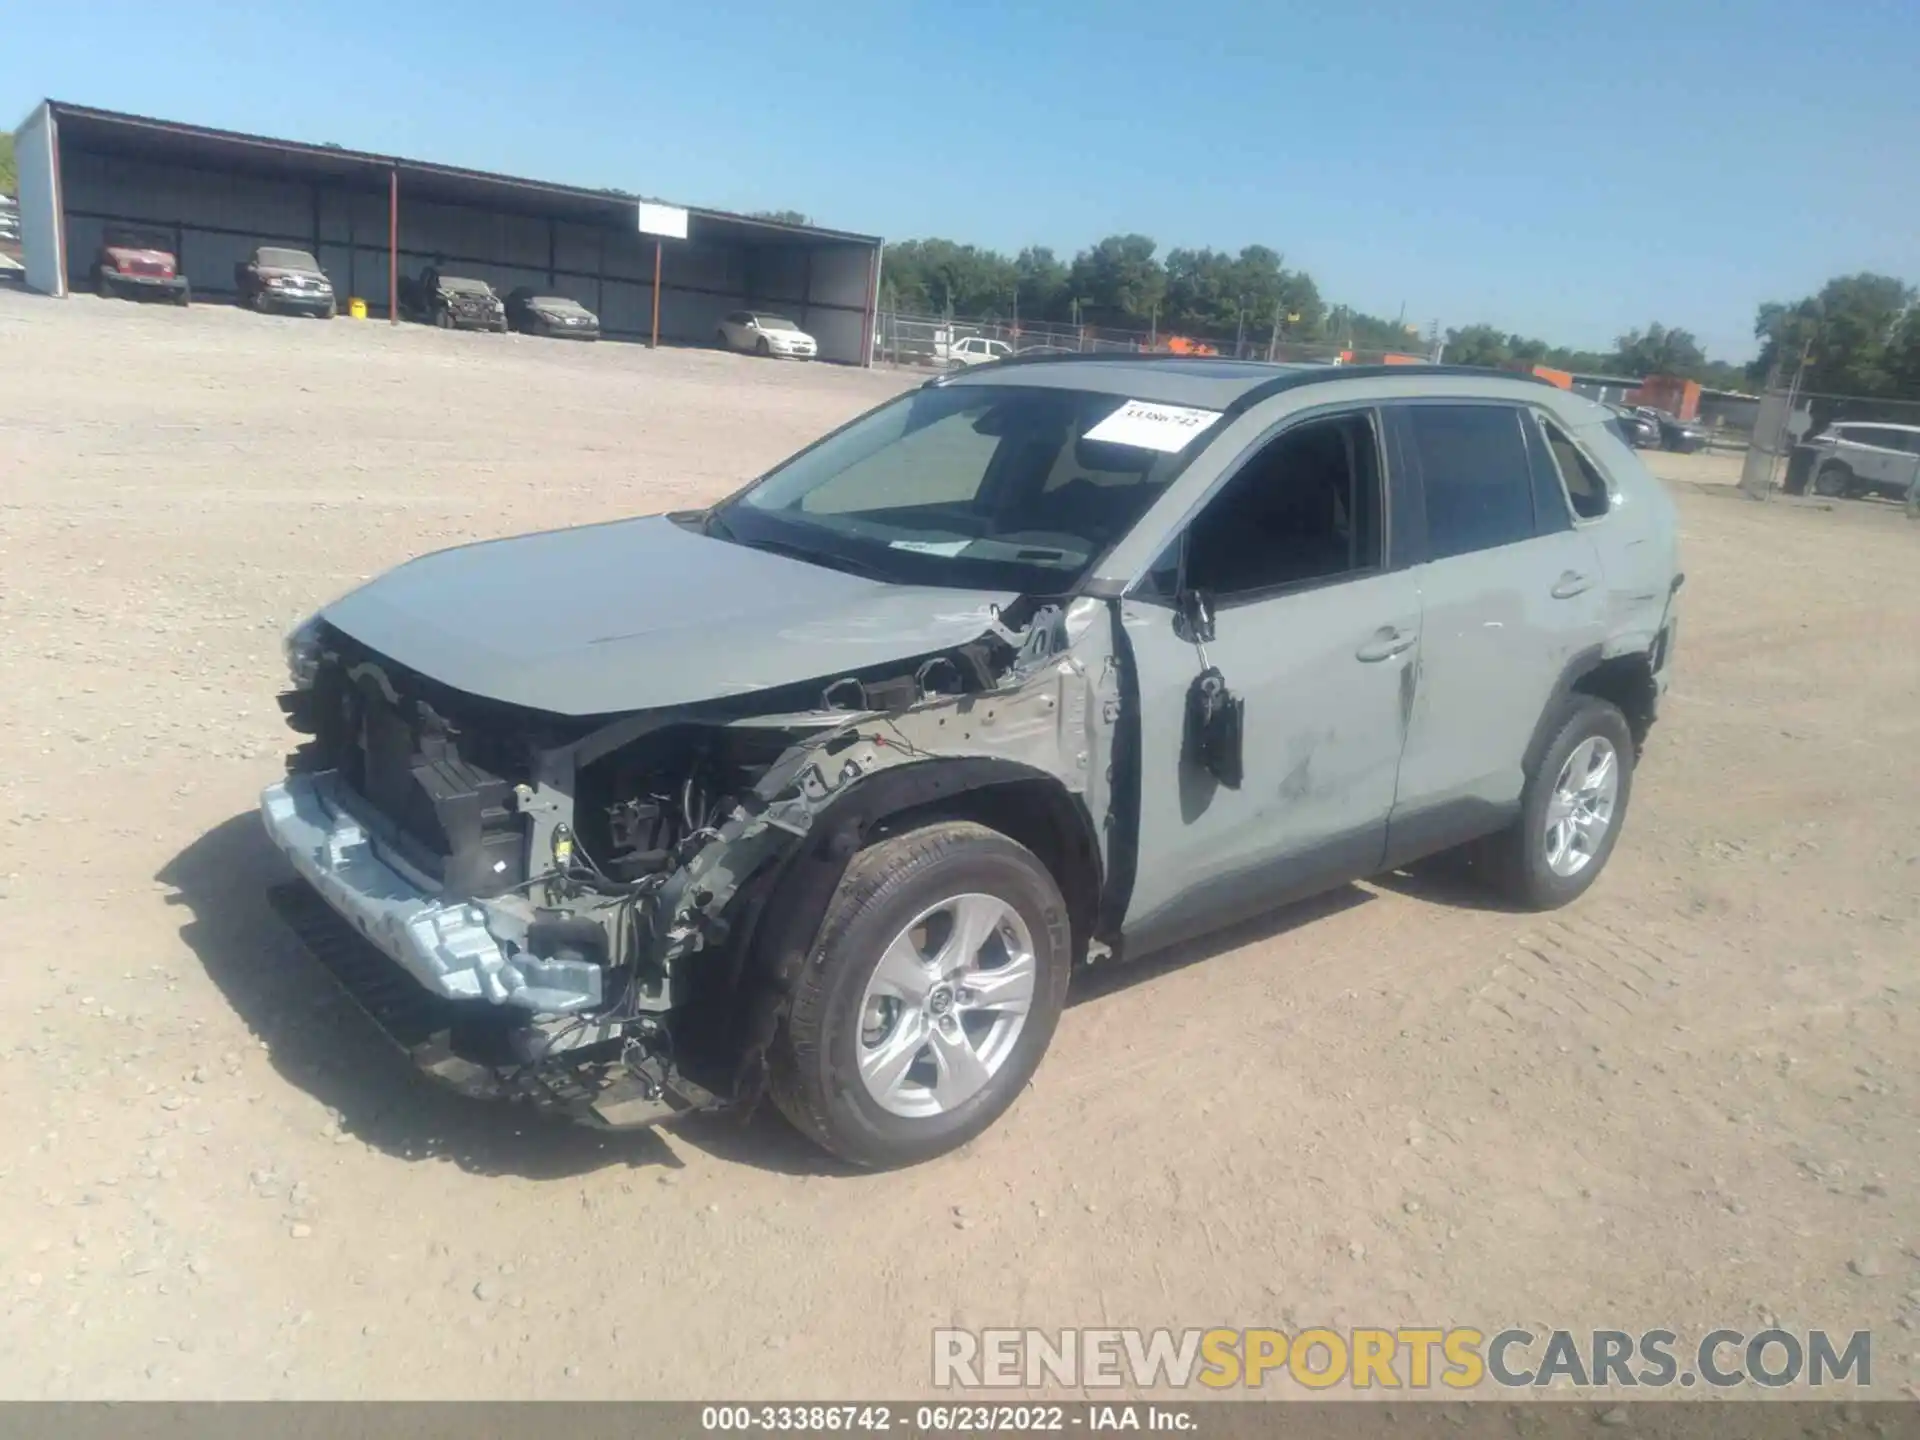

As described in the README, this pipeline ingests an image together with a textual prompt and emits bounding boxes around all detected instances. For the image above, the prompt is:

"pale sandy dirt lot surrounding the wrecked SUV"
[0,294,1920,1398]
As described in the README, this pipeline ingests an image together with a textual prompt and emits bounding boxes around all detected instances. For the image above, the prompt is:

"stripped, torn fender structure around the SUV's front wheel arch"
[462,599,1131,1127]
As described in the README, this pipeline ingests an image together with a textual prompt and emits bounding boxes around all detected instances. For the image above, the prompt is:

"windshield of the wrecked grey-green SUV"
[712,386,1192,595]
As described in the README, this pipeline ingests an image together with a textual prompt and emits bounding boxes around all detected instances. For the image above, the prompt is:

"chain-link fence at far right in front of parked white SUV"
[1740,384,1920,515]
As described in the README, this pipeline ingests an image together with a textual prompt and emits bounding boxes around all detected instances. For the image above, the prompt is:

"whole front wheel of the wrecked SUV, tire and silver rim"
[770,820,1071,1167]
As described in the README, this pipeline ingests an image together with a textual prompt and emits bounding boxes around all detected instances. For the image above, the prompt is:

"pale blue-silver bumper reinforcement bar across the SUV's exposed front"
[259,772,601,1016]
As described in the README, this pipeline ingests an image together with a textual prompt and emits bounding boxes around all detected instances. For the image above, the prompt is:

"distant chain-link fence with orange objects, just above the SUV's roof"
[874,311,1388,369]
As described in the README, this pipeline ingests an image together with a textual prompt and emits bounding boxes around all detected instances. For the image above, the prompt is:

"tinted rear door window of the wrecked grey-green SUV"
[1407,405,1534,561]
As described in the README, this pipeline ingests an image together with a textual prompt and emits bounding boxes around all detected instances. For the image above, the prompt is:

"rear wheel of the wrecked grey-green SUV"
[1482,695,1634,910]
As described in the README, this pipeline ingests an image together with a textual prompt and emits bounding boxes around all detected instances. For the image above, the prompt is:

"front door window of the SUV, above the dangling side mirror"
[1185,413,1380,601]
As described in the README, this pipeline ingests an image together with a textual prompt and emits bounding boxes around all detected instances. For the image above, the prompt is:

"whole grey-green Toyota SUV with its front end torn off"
[261,355,1680,1165]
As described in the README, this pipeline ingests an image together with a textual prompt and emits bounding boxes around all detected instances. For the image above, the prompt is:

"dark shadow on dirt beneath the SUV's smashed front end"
[156,814,851,1179]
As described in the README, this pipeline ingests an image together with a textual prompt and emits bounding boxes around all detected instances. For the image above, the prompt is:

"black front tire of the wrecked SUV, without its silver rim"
[768,820,1073,1167]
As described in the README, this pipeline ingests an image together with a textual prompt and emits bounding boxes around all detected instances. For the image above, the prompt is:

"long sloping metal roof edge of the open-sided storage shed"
[46,100,881,246]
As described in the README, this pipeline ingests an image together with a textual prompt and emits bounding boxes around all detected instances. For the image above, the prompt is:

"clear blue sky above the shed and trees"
[0,0,1920,359]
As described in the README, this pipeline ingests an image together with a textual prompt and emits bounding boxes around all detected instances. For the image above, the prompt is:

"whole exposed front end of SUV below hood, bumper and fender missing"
[263,599,1119,1125]
